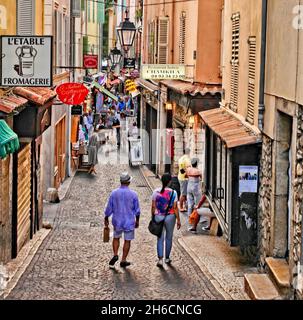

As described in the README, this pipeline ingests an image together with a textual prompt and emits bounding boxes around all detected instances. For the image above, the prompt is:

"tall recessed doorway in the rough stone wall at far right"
[273,112,293,259]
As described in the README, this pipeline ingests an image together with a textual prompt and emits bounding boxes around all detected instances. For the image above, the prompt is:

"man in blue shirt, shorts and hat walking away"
[104,172,140,269]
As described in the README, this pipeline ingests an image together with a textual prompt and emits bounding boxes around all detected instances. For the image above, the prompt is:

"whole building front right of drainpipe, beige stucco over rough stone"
[259,0,303,298]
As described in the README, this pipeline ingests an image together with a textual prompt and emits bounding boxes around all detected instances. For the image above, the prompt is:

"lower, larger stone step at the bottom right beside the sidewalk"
[244,273,281,300]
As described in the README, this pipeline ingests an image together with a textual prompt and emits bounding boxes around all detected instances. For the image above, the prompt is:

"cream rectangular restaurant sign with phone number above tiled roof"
[141,64,185,80]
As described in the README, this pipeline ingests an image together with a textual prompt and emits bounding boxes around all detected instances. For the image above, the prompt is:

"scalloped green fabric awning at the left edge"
[0,120,20,159]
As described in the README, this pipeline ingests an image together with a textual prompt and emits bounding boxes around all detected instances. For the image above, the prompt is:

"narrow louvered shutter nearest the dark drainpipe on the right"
[247,37,257,124]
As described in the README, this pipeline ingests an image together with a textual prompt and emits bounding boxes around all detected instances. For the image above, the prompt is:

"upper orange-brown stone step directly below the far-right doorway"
[265,257,290,289]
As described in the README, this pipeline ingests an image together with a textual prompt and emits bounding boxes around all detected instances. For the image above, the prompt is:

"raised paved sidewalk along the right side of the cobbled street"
[142,166,252,300]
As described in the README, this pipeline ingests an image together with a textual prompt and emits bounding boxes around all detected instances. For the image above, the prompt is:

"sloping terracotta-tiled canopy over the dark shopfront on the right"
[199,108,261,148]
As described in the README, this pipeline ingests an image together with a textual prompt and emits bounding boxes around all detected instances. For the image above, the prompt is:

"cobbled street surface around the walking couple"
[7,139,222,300]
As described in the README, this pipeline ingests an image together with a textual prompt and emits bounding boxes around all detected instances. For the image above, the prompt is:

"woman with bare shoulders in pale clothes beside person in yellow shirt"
[185,158,202,233]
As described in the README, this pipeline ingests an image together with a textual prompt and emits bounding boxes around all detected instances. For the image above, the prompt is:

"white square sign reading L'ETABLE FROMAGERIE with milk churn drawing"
[1,36,53,87]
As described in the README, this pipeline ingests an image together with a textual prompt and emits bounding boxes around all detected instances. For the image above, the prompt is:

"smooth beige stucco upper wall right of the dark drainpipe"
[264,0,303,137]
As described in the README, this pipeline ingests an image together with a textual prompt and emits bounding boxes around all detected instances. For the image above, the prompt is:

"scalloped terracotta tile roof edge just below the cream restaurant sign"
[161,80,222,96]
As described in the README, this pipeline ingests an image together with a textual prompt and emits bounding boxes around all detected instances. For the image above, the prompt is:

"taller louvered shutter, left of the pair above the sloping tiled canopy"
[230,13,240,112]
